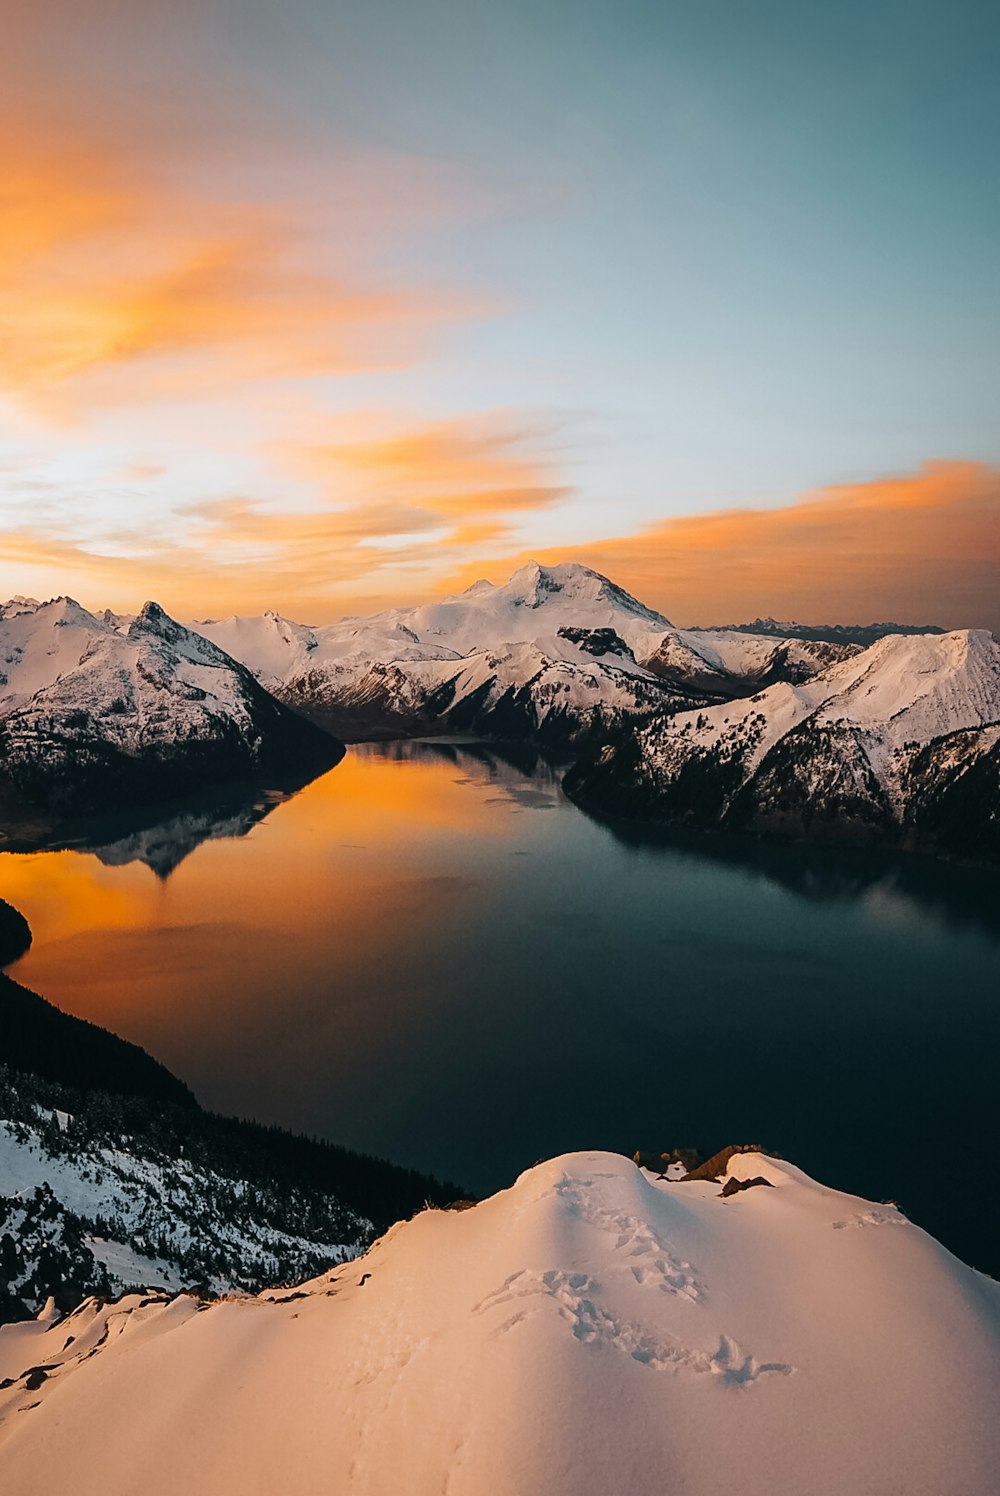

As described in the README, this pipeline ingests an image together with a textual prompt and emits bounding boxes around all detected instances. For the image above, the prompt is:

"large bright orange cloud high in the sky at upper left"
[0,115,487,416]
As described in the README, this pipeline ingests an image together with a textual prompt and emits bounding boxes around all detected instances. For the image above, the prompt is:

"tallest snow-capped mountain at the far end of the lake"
[193,562,849,744]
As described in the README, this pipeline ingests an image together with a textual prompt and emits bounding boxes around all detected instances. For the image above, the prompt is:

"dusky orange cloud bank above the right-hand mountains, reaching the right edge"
[442,462,1000,631]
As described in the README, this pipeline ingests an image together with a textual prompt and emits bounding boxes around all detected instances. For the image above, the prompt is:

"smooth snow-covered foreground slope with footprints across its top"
[0,1153,1000,1496]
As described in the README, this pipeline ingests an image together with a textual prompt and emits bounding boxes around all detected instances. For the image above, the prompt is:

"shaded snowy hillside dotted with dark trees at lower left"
[0,1068,374,1319]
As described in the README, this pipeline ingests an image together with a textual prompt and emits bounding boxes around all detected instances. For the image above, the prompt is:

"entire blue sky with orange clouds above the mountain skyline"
[0,0,1000,628]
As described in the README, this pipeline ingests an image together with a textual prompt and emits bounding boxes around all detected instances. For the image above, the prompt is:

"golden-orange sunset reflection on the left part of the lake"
[0,749,543,1104]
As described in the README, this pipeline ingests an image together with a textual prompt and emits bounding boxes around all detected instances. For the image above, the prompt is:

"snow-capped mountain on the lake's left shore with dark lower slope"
[0,597,340,820]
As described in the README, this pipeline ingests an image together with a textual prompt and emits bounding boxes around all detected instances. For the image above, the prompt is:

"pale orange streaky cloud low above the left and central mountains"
[3,413,567,621]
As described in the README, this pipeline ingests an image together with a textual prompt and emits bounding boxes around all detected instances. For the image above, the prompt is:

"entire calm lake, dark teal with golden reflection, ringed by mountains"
[0,744,1000,1275]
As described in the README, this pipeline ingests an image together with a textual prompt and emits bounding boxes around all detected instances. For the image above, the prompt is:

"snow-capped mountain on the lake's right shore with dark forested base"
[566,630,1000,854]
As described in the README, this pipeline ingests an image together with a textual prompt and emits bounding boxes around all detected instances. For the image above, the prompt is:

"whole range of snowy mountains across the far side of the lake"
[0,562,1000,871]
